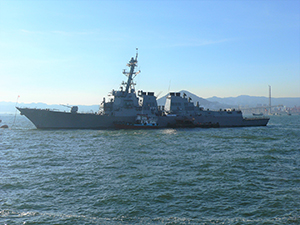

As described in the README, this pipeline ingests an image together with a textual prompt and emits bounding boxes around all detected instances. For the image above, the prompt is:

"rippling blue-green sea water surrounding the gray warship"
[0,115,300,224]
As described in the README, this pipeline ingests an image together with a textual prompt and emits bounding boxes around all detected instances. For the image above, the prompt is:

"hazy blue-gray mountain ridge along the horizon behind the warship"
[0,90,300,113]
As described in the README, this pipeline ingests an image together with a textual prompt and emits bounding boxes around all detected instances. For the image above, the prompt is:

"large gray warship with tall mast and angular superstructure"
[16,53,269,129]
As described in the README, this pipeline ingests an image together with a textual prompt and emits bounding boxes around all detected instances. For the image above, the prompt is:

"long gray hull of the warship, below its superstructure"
[17,107,269,129]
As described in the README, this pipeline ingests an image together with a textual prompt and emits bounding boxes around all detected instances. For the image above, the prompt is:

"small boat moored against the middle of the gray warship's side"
[114,114,159,129]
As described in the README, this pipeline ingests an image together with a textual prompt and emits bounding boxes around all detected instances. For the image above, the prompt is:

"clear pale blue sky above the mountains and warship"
[0,0,300,105]
